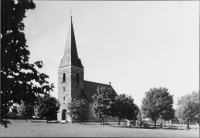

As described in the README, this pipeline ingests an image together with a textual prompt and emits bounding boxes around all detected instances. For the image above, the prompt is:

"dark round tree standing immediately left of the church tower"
[37,96,60,122]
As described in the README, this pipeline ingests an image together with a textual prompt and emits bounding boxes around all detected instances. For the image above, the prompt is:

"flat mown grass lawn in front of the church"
[0,120,199,138]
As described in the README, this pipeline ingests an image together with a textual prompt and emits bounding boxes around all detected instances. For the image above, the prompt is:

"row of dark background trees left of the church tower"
[7,94,60,122]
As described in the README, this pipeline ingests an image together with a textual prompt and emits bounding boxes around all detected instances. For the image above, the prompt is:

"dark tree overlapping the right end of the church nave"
[112,94,139,125]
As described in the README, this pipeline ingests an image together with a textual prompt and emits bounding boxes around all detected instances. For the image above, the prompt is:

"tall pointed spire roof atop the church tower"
[59,16,83,68]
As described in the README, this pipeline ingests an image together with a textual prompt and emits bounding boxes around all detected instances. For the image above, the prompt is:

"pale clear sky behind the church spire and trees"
[24,1,199,107]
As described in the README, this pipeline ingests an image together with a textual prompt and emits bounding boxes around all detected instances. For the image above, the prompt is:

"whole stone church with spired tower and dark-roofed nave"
[57,16,114,122]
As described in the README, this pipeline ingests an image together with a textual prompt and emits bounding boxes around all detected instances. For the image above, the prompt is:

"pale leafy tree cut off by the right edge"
[176,92,199,129]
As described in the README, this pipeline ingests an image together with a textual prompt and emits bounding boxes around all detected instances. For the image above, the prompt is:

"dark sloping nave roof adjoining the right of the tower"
[81,81,115,102]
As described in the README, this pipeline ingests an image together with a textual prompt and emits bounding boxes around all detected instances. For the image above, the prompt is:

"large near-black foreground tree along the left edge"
[0,0,54,126]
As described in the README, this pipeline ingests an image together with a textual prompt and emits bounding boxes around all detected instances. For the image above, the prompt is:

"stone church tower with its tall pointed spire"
[57,16,84,122]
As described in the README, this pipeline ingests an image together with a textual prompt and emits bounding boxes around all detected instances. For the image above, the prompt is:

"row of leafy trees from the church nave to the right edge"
[91,87,200,129]
